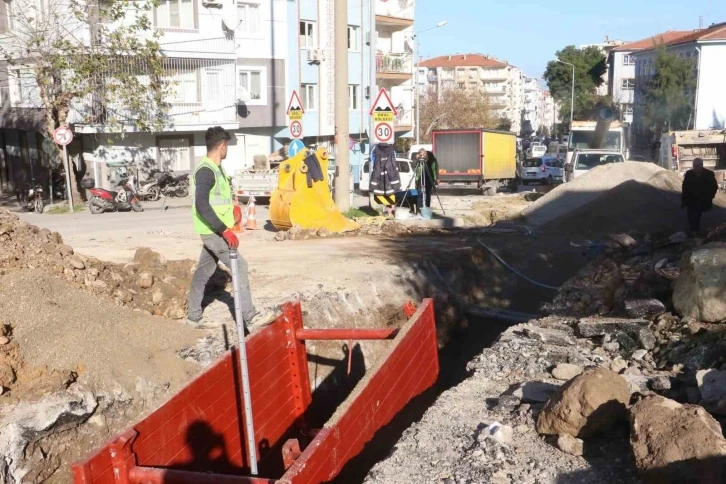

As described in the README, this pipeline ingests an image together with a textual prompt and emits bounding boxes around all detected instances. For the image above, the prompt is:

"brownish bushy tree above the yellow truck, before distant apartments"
[420,89,504,143]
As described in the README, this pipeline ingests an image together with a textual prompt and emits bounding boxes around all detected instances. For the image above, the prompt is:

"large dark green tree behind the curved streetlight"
[544,45,607,123]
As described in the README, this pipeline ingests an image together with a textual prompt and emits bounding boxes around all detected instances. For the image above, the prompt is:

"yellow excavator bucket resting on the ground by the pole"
[270,149,360,232]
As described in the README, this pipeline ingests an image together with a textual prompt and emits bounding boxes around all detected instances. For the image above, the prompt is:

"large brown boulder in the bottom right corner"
[630,396,726,484]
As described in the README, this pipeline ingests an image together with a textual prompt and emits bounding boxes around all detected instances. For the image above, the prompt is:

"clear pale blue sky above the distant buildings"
[416,0,726,78]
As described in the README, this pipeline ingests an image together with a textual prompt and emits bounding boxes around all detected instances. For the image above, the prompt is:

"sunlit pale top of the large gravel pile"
[523,162,677,227]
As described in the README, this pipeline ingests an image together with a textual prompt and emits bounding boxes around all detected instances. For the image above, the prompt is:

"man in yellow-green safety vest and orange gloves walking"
[187,126,272,329]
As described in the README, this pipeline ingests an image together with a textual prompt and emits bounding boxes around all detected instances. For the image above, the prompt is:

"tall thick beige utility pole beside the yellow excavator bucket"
[334,0,350,212]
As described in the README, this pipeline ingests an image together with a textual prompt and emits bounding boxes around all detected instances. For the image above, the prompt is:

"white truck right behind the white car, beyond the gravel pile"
[565,108,628,165]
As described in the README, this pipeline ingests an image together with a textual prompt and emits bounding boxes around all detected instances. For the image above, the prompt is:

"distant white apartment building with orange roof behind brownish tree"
[418,54,525,133]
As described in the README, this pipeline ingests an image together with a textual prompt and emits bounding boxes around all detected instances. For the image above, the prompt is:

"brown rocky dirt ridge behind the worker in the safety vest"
[0,209,228,319]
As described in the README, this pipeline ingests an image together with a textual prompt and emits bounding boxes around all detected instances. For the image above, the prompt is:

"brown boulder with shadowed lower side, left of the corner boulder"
[537,368,630,438]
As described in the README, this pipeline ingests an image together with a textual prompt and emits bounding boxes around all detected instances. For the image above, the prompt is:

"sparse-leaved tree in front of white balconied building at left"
[0,0,169,203]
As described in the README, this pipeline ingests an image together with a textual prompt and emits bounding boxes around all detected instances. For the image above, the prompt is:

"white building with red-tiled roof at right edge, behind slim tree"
[633,22,726,145]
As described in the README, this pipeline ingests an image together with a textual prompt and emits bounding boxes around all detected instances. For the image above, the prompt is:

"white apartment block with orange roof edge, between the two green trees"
[607,30,693,123]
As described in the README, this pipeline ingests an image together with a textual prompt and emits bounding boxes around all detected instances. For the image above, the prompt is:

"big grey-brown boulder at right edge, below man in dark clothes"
[673,243,726,323]
